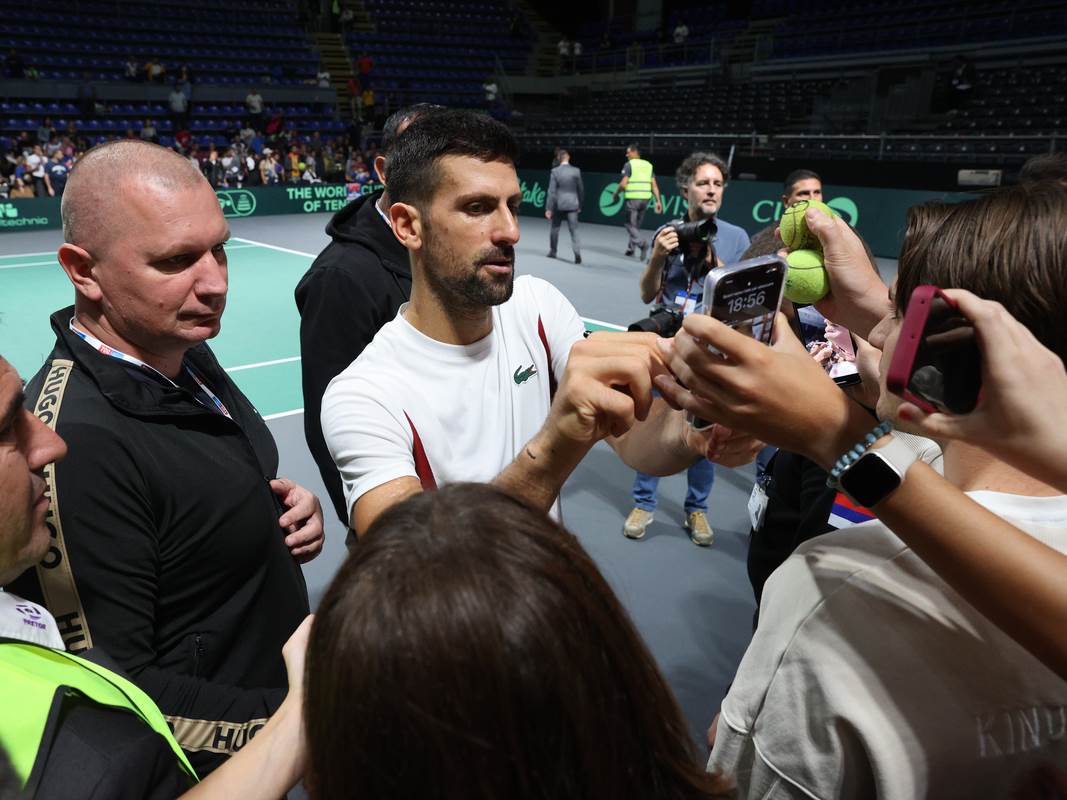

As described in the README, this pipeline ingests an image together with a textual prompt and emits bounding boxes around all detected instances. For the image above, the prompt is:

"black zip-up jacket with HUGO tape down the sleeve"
[10,307,308,774]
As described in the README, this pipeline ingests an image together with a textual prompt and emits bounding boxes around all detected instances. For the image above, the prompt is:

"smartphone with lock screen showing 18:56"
[686,255,789,430]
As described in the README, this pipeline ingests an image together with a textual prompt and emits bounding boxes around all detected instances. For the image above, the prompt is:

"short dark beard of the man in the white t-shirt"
[423,226,515,317]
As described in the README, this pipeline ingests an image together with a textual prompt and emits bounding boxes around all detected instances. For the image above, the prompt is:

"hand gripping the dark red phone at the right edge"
[896,289,1067,492]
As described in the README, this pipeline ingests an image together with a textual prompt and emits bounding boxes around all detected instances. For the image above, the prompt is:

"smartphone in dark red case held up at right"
[886,285,982,414]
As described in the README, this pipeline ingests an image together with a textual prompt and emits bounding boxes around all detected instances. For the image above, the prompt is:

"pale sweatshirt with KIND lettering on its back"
[707,492,1067,800]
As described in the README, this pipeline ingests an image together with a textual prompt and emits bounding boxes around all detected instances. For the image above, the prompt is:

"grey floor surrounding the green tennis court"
[0,208,895,741]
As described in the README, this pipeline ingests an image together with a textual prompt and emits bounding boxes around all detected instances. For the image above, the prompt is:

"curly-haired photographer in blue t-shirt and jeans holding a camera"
[622,153,749,547]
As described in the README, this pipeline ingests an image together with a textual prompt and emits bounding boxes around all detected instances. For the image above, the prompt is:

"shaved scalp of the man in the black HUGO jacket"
[60,140,207,252]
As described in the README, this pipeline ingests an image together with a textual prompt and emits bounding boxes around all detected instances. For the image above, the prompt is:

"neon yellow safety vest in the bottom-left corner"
[0,641,197,785]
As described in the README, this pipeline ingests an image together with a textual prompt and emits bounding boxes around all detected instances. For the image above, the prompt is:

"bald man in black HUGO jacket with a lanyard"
[11,141,322,774]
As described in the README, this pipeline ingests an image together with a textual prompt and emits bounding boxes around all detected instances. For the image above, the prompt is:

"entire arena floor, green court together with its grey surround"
[0,214,895,742]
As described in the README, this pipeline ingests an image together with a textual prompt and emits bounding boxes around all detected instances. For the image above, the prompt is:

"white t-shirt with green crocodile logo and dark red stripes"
[321,275,585,516]
